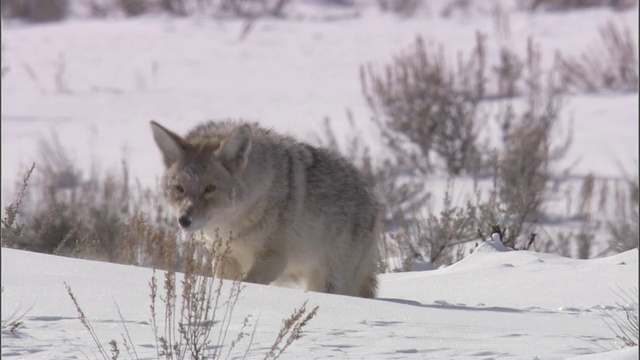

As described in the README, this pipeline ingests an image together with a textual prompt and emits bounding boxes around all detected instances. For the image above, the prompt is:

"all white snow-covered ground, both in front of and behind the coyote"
[2,0,638,359]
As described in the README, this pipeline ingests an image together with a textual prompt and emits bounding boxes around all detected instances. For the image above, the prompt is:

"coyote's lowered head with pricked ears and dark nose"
[151,121,252,231]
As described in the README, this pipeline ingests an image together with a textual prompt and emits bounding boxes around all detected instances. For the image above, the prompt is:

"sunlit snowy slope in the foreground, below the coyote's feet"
[2,243,638,359]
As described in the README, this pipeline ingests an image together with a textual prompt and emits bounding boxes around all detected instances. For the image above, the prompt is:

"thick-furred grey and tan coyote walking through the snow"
[151,121,380,297]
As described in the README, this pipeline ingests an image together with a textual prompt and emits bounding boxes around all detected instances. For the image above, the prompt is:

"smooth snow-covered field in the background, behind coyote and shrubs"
[2,1,638,191]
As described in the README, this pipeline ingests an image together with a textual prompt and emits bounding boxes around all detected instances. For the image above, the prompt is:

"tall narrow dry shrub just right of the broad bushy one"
[495,39,572,247]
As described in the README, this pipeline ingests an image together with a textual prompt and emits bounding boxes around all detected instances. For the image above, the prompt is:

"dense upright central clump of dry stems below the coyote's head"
[150,232,248,359]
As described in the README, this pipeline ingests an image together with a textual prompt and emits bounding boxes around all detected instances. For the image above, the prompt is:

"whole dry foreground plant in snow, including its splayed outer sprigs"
[65,231,318,360]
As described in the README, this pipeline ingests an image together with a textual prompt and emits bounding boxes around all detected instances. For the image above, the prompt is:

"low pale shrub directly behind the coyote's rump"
[316,114,497,272]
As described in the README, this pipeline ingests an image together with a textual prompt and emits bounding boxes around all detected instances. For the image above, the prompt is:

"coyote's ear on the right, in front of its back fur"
[216,125,252,175]
